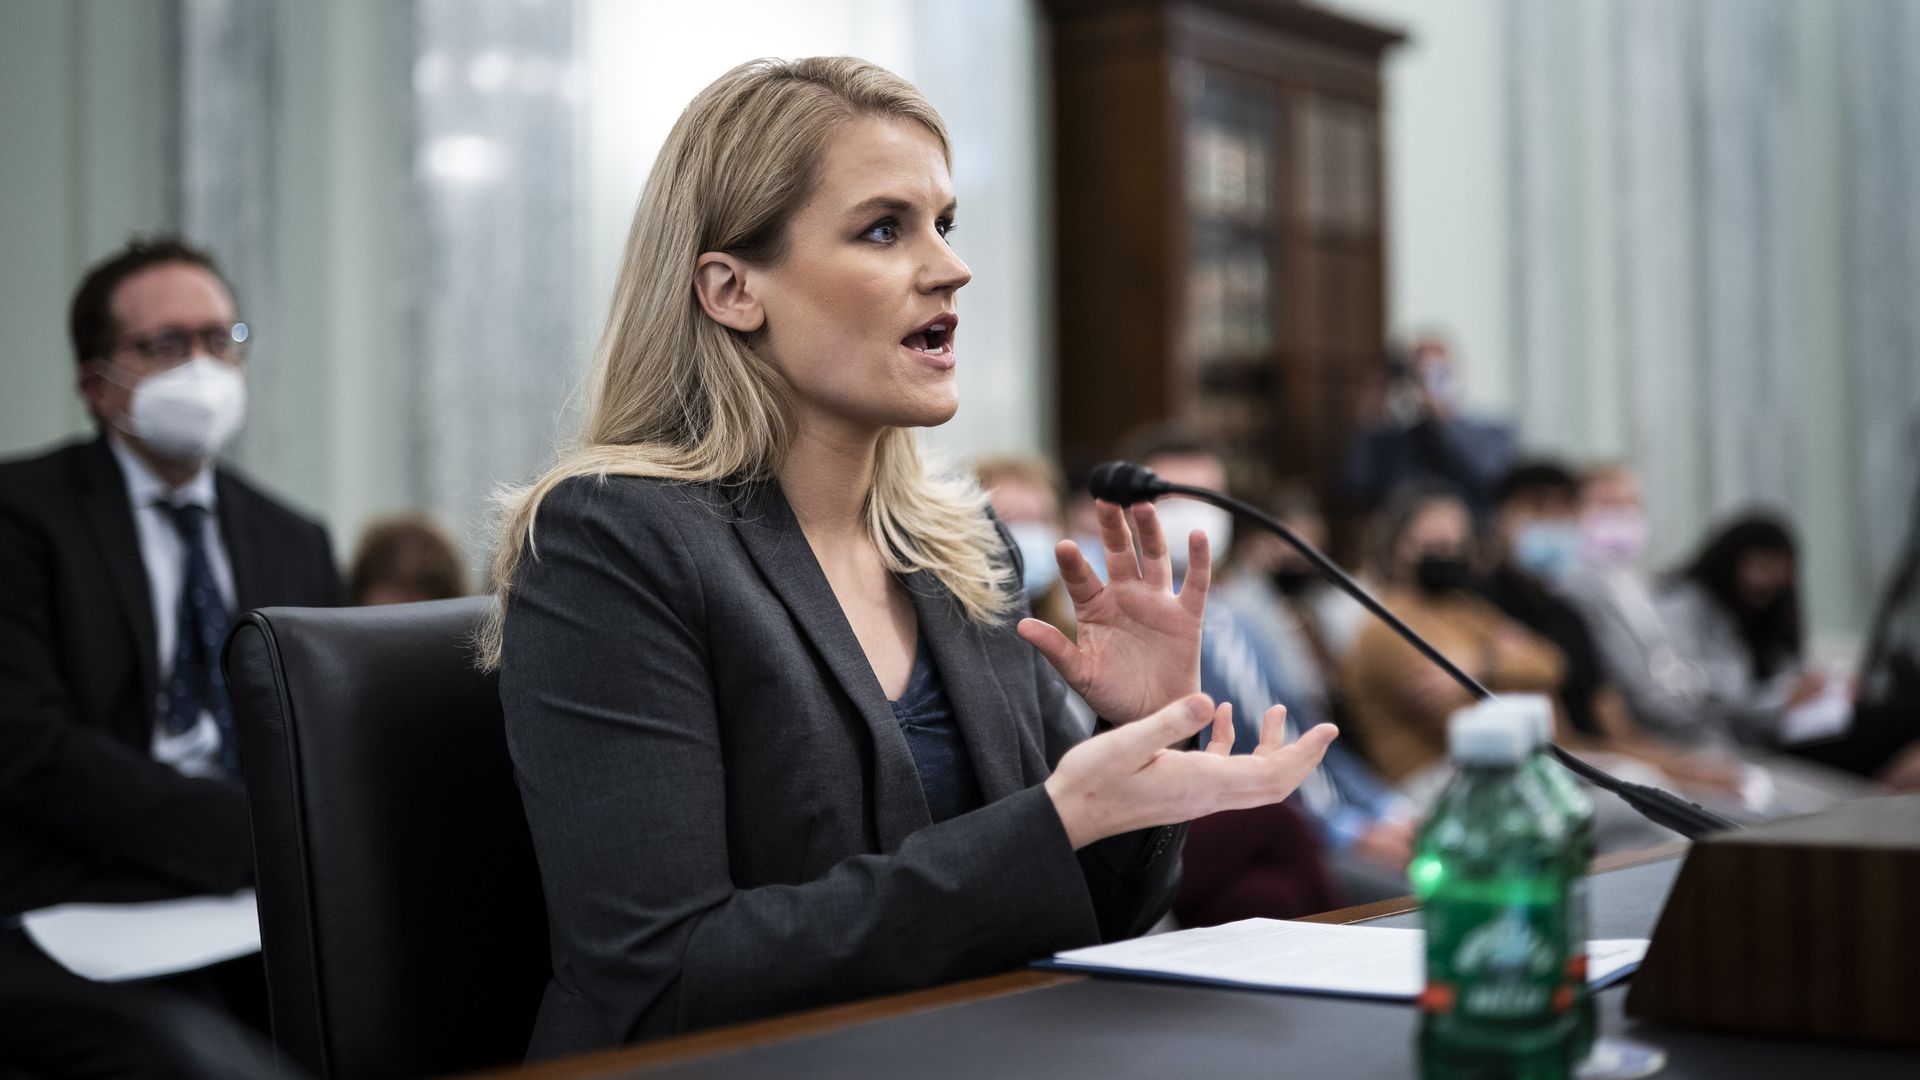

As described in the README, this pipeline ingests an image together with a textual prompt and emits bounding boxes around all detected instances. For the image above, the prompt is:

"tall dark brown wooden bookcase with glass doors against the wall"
[1046,0,1402,519]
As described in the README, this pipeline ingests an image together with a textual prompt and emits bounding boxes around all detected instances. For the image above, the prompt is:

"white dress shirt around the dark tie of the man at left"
[108,432,236,776]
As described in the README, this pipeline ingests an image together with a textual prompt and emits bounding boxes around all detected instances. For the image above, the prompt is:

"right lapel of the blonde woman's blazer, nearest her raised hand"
[906,571,1027,803]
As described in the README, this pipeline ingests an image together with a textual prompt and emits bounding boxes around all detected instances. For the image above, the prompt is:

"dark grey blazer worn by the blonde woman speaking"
[499,477,1185,1057]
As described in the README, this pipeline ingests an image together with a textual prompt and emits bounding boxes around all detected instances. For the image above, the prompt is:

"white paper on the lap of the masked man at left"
[19,890,259,982]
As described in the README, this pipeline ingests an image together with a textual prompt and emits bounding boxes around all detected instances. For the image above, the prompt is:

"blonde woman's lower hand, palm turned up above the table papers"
[1046,694,1340,849]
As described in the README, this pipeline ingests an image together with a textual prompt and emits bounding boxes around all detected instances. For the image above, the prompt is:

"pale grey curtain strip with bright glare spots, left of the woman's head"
[399,0,576,561]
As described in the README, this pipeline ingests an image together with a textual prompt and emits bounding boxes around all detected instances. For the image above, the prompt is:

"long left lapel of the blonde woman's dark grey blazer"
[733,482,929,851]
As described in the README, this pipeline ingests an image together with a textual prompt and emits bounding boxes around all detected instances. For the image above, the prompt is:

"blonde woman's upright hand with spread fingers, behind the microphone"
[1020,502,1212,724]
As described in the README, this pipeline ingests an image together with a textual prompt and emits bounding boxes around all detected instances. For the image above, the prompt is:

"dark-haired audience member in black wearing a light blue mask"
[1478,461,1740,794]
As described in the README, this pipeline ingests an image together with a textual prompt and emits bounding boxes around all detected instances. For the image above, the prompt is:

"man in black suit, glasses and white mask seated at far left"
[0,238,340,1038]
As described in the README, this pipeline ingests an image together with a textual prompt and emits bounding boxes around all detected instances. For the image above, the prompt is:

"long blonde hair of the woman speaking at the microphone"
[476,56,1010,667]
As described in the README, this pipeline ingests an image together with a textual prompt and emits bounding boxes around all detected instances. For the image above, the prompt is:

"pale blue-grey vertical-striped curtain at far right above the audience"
[1505,0,1920,636]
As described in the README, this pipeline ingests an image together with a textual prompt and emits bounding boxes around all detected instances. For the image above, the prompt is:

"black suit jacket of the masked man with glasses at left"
[0,438,340,913]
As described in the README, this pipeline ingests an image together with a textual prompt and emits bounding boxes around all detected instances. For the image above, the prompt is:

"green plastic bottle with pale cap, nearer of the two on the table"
[1407,701,1578,1080]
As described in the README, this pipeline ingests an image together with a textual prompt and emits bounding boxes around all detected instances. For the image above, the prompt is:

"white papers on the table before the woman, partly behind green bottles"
[1041,919,1647,1001]
